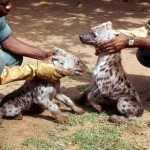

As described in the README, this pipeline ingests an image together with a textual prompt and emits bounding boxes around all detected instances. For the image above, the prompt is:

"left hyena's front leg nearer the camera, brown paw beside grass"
[38,99,68,124]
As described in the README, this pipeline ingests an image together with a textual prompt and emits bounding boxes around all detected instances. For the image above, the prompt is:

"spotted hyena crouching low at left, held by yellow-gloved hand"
[0,47,86,123]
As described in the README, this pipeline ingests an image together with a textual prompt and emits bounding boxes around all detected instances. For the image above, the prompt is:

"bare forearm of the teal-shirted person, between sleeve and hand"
[2,36,47,60]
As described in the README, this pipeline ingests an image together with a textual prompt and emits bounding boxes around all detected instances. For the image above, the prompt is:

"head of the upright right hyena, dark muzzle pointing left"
[79,21,119,46]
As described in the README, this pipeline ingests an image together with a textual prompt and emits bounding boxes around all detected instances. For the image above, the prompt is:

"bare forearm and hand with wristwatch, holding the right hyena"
[96,33,150,54]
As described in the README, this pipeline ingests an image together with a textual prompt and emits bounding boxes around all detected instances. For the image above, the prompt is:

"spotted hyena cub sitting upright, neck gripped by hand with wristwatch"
[79,22,143,123]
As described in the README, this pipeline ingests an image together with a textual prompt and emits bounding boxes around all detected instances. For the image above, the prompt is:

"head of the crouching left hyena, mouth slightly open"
[44,47,87,75]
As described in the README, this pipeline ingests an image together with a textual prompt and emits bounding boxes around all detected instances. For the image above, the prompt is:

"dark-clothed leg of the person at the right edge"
[136,49,150,67]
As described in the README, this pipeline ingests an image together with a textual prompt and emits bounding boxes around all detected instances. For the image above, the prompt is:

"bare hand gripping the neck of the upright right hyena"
[95,33,130,55]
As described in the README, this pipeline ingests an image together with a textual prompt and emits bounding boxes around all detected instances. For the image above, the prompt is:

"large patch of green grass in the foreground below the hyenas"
[22,112,144,150]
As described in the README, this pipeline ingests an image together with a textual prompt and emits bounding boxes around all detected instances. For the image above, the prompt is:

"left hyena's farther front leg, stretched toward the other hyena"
[55,93,84,115]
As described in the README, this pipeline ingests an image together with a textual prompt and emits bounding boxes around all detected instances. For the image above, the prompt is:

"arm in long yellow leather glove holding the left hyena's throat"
[0,62,71,85]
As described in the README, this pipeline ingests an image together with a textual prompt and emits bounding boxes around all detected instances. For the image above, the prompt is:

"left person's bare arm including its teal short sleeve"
[0,17,52,60]
